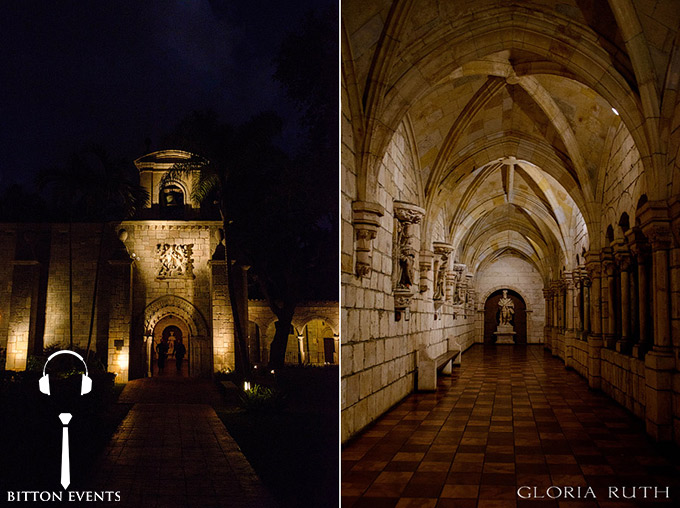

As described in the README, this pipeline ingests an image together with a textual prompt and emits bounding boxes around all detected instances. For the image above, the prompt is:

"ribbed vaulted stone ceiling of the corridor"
[342,0,680,280]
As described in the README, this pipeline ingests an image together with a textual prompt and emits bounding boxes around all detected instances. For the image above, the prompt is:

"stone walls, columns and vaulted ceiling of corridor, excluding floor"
[341,0,680,443]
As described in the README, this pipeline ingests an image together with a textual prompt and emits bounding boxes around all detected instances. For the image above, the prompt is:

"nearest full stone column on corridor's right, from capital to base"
[638,202,675,441]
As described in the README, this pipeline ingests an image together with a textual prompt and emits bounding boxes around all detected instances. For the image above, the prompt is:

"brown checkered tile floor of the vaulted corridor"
[342,345,680,508]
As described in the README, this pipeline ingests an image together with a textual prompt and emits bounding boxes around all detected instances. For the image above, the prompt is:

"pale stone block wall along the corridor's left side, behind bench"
[341,120,476,441]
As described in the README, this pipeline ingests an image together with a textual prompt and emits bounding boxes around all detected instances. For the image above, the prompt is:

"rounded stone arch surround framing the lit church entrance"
[143,295,213,377]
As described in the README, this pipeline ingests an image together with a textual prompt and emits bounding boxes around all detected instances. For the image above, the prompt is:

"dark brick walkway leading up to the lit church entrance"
[93,379,275,508]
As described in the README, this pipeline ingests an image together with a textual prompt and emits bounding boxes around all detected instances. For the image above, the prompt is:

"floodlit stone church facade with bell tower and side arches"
[0,150,339,382]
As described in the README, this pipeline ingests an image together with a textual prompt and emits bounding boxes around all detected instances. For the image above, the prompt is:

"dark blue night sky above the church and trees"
[0,0,338,188]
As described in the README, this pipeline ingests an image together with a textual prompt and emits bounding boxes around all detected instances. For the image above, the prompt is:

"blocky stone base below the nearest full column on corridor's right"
[645,349,675,441]
